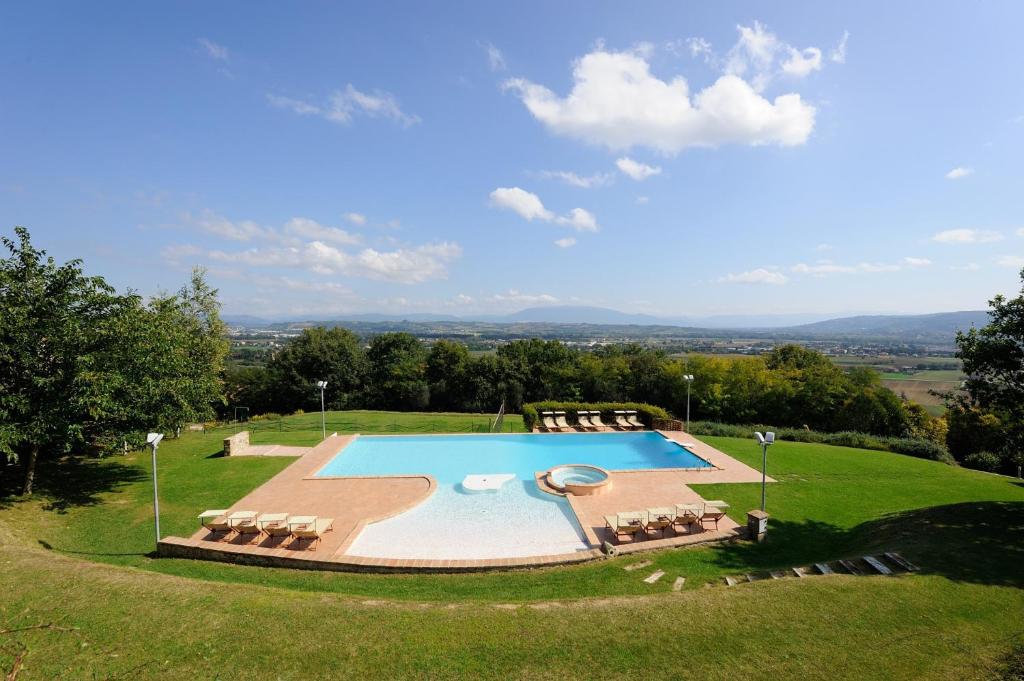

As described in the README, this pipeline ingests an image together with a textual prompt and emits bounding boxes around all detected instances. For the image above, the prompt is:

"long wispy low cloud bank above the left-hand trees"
[173,211,462,284]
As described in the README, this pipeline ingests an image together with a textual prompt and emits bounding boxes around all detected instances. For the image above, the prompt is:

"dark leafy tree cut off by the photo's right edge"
[950,269,1024,467]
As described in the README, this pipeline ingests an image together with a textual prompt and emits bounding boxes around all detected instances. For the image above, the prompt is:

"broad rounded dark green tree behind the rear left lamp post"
[266,327,367,414]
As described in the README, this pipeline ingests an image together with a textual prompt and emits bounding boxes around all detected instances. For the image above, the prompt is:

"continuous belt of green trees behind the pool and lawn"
[226,328,944,441]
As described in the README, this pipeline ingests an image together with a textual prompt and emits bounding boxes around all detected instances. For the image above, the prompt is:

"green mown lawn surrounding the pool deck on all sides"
[0,413,1024,679]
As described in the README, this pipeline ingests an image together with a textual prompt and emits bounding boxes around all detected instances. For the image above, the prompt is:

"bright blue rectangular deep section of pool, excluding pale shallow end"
[316,431,711,485]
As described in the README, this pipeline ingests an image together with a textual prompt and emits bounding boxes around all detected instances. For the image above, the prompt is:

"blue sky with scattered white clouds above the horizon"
[0,2,1024,317]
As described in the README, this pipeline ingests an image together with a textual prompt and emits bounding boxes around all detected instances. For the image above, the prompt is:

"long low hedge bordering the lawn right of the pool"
[689,421,956,465]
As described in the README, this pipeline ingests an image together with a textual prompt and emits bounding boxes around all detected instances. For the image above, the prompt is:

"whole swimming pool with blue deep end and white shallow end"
[327,432,711,559]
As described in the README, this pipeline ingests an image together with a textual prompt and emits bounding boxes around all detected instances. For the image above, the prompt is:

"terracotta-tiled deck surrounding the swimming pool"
[160,431,771,572]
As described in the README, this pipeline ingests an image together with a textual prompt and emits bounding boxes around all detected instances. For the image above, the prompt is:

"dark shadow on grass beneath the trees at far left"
[0,455,146,513]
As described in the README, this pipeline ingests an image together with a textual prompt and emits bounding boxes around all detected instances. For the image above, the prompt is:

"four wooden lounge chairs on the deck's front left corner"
[199,509,334,551]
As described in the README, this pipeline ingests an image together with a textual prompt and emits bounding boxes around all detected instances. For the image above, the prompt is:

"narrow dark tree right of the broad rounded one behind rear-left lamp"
[367,333,430,411]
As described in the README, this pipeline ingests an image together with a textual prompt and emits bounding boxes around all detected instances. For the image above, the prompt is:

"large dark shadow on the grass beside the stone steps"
[714,502,1024,588]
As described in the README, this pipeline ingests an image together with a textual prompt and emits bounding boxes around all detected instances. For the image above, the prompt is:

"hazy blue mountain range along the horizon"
[224,305,988,340]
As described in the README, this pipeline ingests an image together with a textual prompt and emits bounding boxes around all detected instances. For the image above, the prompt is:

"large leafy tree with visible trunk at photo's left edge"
[0,227,137,495]
